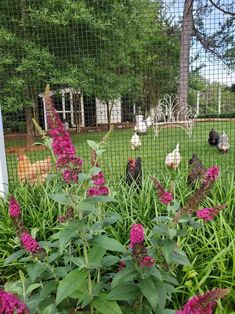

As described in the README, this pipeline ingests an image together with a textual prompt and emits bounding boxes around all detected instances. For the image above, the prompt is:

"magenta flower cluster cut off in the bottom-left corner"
[0,290,29,314]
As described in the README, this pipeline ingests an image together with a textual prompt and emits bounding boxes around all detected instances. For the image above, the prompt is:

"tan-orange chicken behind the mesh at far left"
[17,154,51,183]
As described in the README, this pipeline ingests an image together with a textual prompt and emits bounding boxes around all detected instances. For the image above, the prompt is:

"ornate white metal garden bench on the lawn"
[150,95,196,137]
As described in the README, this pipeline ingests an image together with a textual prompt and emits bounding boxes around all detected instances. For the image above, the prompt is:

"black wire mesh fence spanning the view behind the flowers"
[0,0,235,186]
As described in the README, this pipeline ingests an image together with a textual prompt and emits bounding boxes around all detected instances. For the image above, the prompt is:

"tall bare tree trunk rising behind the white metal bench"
[177,0,193,120]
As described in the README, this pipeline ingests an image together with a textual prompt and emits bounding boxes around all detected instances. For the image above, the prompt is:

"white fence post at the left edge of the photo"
[0,106,8,197]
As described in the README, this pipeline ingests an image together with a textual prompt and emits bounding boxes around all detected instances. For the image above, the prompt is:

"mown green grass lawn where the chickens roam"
[6,121,235,184]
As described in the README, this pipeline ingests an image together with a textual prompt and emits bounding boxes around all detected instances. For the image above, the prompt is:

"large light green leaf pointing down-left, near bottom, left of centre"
[56,269,88,305]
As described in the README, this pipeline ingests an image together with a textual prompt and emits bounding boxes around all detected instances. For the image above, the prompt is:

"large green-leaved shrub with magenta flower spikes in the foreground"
[0,84,229,314]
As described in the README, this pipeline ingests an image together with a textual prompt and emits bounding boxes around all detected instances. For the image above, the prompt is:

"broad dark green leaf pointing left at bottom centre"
[106,282,140,301]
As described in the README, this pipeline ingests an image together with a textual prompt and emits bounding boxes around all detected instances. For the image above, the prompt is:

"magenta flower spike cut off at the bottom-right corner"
[176,288,228,314]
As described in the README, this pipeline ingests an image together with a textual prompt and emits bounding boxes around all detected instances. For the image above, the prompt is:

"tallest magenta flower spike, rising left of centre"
[46,92,82,183]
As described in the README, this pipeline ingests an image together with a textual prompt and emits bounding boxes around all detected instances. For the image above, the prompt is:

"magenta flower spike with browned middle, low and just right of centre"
[130,224,155,268]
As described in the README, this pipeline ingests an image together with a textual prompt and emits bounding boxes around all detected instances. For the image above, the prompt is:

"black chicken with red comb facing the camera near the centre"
[126,157,142,188]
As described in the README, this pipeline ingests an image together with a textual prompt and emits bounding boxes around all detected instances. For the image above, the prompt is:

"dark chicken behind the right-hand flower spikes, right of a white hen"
[187,154,206,185]
